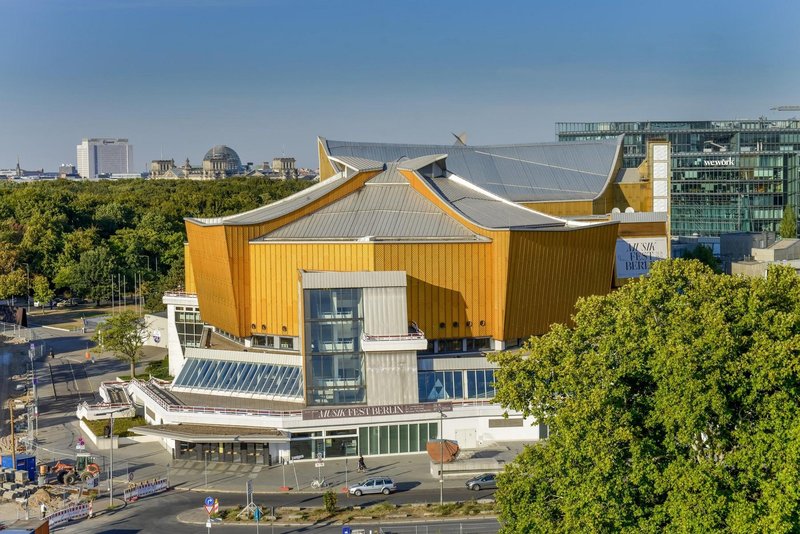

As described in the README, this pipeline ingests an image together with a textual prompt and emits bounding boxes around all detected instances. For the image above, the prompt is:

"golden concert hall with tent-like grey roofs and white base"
[129,137,670,463]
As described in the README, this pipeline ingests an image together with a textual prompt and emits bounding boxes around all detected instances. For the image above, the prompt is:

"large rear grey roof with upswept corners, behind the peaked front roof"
[322,136,622,202]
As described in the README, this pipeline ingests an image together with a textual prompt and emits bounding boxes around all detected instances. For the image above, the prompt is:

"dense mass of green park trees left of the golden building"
[0,178,308,310]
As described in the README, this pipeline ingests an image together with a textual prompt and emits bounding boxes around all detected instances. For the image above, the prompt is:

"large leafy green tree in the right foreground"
[493,260,800,533]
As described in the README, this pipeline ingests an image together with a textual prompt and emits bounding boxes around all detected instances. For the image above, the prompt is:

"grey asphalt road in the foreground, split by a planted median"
[56,490,500,534]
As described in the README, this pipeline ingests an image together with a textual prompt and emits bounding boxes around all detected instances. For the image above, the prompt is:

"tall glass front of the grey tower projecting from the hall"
[304,288,366,406]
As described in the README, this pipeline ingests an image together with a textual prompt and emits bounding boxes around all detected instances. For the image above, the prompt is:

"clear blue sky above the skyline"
[0,0,800,171]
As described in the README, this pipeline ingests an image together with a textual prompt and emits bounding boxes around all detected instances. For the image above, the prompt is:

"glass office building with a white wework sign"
[556,122,800,240]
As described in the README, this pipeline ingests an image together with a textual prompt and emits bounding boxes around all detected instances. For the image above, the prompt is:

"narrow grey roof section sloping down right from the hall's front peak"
[427,178,564,228]
